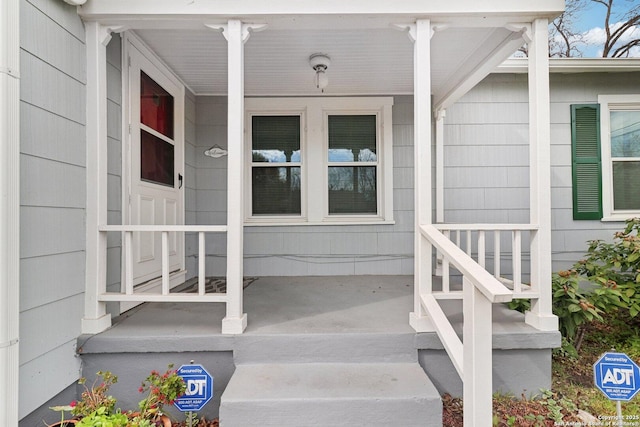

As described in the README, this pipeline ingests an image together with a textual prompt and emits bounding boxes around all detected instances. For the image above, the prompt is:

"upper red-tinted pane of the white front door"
[140,71,173,139]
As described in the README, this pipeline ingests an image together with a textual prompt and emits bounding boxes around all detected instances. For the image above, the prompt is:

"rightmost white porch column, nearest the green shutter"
[525,19,558,331]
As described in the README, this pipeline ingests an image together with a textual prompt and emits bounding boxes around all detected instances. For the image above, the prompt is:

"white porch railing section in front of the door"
[98,225,229,304]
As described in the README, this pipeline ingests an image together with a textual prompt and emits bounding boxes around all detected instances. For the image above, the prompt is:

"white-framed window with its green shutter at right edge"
[571,95,640,221]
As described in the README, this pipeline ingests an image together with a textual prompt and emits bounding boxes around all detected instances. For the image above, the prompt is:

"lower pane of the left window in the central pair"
[251,167,301,215]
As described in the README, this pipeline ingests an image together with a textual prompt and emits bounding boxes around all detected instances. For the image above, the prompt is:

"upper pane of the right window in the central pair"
[329,115,377,162]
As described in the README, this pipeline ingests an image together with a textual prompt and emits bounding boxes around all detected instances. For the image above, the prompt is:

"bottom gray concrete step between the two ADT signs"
[220,363,442,427]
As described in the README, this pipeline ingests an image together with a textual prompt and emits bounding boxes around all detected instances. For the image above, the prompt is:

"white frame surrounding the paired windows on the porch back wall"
[245,97,394,225]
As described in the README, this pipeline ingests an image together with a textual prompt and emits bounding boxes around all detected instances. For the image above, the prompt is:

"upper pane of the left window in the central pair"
[251,116,300,163]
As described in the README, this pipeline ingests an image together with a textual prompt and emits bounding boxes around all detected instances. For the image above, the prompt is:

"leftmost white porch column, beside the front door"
[82,22,111,334]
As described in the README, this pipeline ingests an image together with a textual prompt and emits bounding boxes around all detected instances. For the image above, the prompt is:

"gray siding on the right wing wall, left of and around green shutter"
[444,73,639,271]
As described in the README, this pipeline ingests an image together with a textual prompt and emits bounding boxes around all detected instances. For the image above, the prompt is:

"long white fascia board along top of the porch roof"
[78,0,564,28]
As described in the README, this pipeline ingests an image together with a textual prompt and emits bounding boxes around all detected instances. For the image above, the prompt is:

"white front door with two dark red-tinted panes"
[125,38,185,285]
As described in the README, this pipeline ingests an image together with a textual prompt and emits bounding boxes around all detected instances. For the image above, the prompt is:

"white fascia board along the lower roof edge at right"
[500,58,640,74]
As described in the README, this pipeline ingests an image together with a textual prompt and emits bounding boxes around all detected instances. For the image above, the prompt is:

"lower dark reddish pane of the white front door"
[140,130,174,187]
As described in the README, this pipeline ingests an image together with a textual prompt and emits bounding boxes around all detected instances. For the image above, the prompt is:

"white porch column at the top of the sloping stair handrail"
[409,19,432,332]
